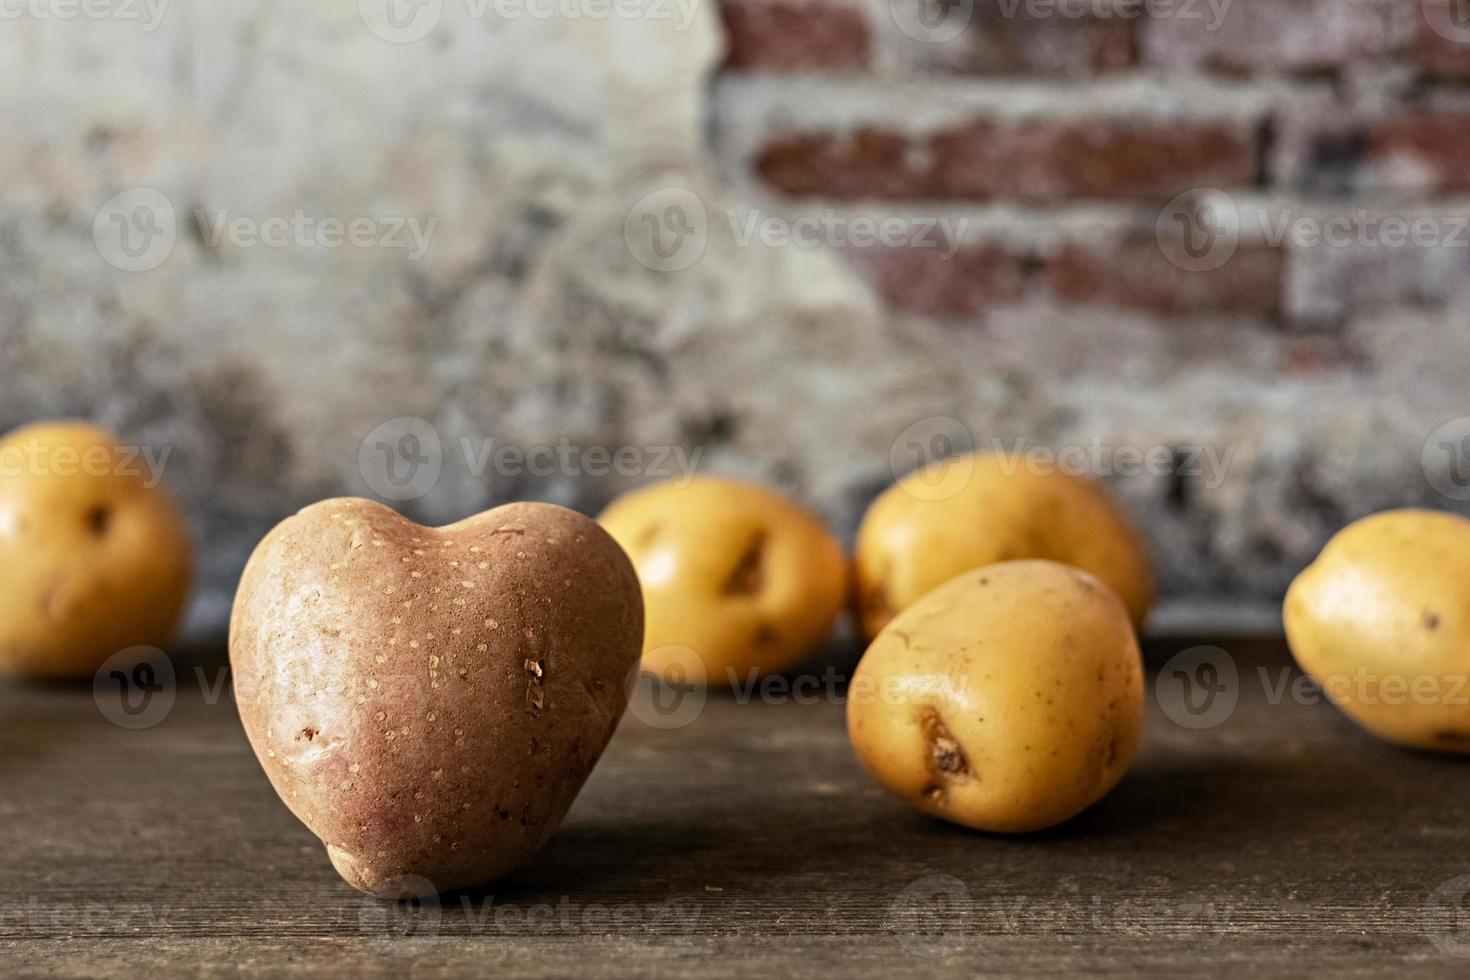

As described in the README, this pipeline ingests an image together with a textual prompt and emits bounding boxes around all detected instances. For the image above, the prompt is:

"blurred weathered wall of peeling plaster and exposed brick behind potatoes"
[0,0,1470,635]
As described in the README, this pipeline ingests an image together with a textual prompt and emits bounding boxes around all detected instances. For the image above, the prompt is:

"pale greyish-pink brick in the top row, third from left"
[1141,0,1417,73]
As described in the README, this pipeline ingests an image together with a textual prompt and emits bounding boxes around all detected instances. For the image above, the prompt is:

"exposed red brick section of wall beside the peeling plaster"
[713,0,1470,326]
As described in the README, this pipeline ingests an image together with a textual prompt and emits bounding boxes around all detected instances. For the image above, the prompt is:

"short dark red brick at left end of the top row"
[720,0,872,72]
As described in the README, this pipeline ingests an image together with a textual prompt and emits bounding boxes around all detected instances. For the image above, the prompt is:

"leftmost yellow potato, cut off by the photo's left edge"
[0,422,193,677]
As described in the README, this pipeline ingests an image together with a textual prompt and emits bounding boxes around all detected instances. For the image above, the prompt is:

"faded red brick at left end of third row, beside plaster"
[848,244,1033,317]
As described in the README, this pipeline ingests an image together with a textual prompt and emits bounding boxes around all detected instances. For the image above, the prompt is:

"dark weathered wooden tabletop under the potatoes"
[0,642,1470,977]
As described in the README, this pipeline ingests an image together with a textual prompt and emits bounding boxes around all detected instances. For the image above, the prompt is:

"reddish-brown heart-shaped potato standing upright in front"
[229,500,642,898]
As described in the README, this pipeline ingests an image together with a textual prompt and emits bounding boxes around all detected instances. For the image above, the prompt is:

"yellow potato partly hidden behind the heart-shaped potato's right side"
[600,478,847,683]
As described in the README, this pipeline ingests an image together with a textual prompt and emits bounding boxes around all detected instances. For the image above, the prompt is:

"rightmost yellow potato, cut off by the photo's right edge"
[1283,510,1470,752]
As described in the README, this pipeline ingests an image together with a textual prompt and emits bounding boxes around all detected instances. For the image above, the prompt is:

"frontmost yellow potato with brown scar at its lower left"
[847,561,1144,833]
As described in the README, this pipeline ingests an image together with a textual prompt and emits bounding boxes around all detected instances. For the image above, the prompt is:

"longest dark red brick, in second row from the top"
[756,118,1258,201]
